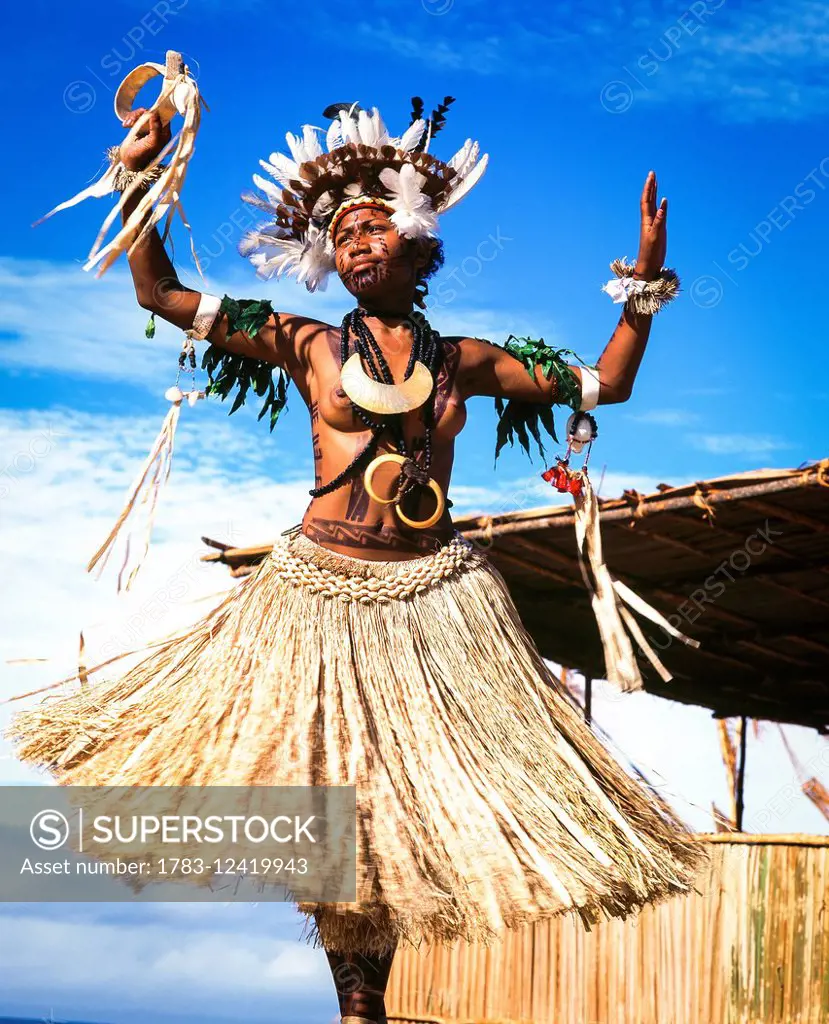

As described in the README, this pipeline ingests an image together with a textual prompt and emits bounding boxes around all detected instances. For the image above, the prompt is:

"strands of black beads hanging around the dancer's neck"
[309,306,443,498]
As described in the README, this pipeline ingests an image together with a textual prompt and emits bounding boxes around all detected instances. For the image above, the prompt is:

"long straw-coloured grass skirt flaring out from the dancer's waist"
[7,535,700,953]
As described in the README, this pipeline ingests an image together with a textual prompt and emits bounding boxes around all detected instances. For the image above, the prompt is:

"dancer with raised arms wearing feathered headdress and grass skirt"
[12,97,697,1024]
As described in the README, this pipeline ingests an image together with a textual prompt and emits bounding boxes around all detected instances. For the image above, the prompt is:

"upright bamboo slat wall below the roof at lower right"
[386,836,829,1024]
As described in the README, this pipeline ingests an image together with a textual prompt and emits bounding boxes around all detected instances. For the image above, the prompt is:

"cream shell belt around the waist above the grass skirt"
[270,536,474,603]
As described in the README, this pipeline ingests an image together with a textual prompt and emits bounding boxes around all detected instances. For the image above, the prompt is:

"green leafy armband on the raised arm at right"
[495,334,584,463]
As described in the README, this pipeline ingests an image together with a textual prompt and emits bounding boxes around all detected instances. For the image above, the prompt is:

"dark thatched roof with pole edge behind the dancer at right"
[200,460,829,731]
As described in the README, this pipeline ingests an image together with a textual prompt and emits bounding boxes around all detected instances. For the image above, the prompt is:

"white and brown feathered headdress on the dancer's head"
[238,96,489,292]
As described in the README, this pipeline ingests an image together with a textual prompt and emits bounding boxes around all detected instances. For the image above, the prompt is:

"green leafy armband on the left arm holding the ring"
[202,295,291,430]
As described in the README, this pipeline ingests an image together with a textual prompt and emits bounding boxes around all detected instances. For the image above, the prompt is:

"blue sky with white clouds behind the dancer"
[0,0,829,1024]
